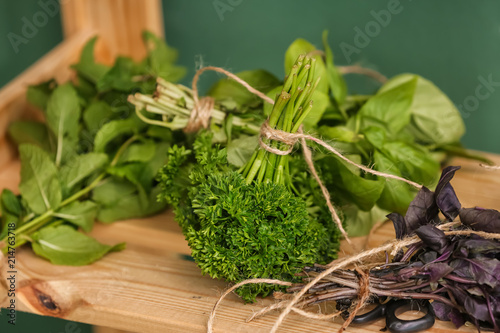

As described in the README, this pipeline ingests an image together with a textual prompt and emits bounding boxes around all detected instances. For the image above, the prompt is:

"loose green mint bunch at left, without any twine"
[0,32,185,265]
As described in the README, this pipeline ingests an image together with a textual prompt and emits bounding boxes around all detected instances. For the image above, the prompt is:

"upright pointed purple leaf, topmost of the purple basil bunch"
[435,166,462,221]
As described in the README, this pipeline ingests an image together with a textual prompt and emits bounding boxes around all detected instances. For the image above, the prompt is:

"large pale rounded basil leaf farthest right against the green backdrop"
[381,74,465,145]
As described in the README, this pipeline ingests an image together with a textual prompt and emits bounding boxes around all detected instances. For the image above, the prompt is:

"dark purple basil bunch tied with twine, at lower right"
[288,167,500,332]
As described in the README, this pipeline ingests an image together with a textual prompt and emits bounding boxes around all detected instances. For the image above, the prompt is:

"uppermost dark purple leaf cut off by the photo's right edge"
[460,207,500,233]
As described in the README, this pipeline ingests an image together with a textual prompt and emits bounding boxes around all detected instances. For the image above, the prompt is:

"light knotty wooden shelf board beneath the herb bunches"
[0,155,500,333]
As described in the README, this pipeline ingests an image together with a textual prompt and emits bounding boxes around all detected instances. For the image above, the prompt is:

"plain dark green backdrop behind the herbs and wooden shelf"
[0,0,500,331]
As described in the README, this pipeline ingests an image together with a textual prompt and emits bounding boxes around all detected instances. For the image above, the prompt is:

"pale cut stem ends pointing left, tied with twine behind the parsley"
[128,78,259,134]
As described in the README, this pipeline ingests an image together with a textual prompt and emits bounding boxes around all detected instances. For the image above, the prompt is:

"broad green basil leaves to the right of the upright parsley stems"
[272,31,489,236]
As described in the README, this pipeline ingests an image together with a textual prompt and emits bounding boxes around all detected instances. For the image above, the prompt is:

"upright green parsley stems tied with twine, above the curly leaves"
[242,55,319,185]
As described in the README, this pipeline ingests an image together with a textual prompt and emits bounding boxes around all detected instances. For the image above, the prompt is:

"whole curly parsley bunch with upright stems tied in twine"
[159,56,339,302]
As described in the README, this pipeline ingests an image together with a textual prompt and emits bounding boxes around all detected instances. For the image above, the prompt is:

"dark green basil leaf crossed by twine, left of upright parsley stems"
[208,69,281,111]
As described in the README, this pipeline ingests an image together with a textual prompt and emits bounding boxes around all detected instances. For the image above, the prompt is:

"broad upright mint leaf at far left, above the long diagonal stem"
[19,144,62,214]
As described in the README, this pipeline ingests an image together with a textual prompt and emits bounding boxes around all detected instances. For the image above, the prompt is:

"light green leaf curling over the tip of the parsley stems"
[285,38,329,94]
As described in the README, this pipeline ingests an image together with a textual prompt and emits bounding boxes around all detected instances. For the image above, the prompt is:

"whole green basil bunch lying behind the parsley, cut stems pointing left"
[131,32,489,236]
